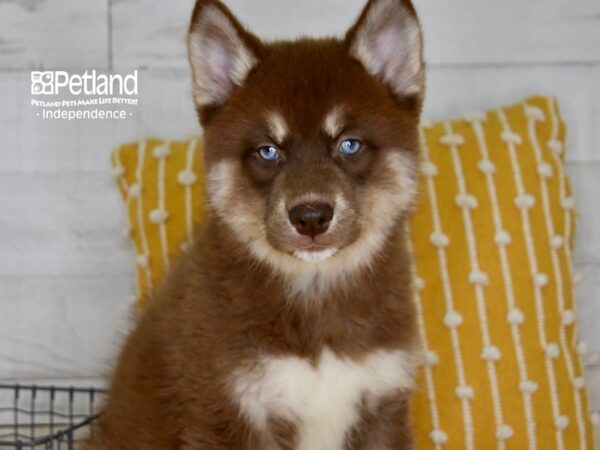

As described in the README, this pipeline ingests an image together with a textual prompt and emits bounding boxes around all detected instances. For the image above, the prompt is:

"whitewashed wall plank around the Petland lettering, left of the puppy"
[0,69,200,173]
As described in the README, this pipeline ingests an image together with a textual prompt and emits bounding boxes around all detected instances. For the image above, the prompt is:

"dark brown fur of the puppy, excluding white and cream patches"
[88,0,422,450]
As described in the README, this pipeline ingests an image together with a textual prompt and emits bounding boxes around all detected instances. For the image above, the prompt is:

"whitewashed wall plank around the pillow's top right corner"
[425,65,600,161]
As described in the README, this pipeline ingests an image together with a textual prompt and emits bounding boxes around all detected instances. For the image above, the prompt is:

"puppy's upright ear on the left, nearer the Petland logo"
[188,0,262,121]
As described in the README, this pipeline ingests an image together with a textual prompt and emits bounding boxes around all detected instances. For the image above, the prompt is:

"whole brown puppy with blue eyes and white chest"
[90,0,424,450]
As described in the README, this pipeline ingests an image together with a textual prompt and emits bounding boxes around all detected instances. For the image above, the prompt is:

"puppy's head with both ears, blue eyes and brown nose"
[188,0,424,296]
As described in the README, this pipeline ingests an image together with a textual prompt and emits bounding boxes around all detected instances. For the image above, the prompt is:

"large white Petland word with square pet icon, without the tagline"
[31,70,138,96]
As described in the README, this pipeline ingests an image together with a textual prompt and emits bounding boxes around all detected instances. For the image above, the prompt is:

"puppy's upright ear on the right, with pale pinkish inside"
[346,0,425,99]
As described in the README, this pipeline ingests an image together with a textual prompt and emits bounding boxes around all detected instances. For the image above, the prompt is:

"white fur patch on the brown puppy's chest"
[233,349,414,450]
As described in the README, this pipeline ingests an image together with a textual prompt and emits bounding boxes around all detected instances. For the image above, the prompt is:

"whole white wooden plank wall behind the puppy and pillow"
[0,0,600,428]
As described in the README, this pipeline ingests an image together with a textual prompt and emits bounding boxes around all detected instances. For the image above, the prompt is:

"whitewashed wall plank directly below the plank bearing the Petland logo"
[0,172,134,276]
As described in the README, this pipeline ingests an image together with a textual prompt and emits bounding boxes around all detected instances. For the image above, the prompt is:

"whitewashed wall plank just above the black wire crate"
[0,274,134,379]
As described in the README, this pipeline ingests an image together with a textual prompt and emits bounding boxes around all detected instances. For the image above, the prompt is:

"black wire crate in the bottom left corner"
[0,384,105,450]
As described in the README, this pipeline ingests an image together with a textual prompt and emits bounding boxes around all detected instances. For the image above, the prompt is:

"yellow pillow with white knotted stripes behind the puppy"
[113,97,593,450]
